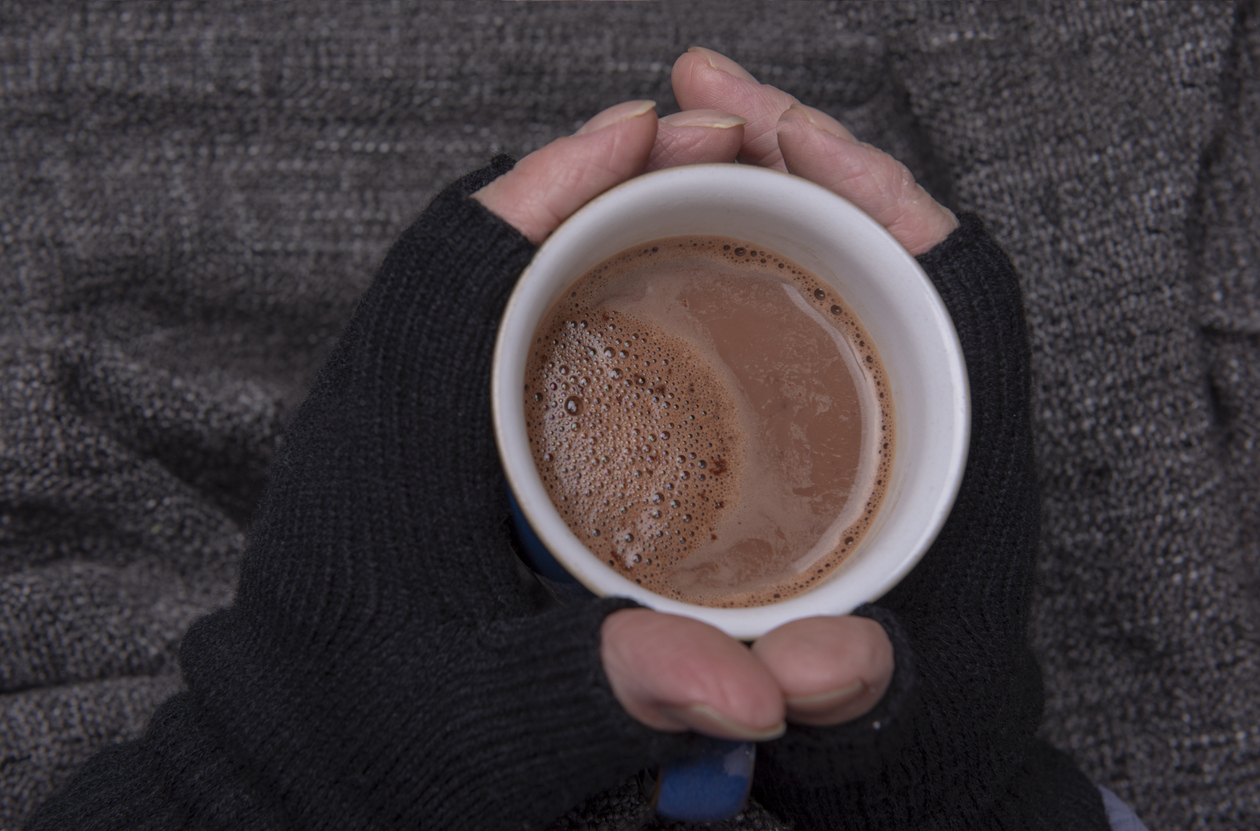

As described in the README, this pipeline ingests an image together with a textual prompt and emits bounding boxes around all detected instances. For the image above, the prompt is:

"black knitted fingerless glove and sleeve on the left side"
[29,160,687,831]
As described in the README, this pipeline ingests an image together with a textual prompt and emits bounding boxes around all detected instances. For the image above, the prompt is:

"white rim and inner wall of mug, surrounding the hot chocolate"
[491,165,970,641]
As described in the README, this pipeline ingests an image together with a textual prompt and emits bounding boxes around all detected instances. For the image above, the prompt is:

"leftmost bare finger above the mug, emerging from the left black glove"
[473,101,656,244]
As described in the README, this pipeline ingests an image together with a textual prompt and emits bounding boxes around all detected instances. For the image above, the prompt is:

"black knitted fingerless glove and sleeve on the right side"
[755,215,1106,831]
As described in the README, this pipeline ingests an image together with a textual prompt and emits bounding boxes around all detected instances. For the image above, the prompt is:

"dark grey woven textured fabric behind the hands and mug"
[0,0,1260,831]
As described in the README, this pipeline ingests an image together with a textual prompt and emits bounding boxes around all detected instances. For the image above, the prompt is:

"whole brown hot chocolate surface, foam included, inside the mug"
[525,237,895,607]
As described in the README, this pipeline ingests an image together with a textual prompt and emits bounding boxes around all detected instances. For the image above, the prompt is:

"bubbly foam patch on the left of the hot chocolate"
[527,301,741,592]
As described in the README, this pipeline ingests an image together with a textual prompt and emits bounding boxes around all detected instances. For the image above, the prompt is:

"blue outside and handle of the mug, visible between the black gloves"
[508,490,757,822]
